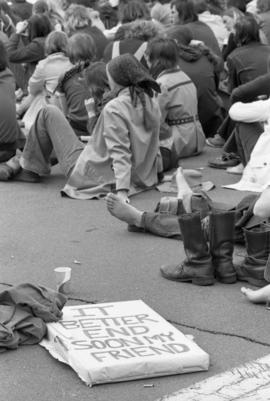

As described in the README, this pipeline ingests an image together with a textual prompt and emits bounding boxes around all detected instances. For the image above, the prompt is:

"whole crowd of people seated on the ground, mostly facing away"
[0,0,270,302]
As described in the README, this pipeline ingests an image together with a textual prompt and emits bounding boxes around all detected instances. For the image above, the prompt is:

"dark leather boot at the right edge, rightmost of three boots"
[236,227,270,287]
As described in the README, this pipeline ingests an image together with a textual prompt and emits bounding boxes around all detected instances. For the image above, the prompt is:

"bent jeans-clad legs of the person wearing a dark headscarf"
[20,106,84,177]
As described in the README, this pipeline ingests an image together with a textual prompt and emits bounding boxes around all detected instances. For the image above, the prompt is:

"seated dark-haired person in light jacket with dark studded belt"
[147,38,205,171]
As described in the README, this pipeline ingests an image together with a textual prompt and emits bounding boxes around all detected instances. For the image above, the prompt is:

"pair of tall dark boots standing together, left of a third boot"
[161,211,237,285]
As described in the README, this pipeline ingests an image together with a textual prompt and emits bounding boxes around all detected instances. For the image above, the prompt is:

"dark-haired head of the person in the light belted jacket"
[147,38,179,79]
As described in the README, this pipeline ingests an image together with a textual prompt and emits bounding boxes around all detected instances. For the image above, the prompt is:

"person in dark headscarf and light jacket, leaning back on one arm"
[0,54,162,201]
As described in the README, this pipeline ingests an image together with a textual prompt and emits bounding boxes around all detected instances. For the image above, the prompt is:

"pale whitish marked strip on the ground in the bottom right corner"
[158,355,270,401]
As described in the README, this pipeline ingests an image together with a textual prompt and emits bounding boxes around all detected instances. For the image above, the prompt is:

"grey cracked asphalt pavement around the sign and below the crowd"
[0,148,270,401]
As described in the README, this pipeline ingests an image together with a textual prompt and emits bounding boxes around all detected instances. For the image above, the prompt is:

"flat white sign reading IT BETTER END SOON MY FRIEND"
[40,300,209,386]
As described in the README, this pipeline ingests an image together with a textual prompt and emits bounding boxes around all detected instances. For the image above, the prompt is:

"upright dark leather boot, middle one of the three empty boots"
[209,211,237,284]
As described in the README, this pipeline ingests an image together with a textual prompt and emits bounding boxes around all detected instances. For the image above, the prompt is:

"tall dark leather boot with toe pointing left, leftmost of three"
[160,212,215,285]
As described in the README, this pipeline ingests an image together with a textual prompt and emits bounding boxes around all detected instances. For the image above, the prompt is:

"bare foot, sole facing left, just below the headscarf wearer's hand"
[105,193,143,227]
